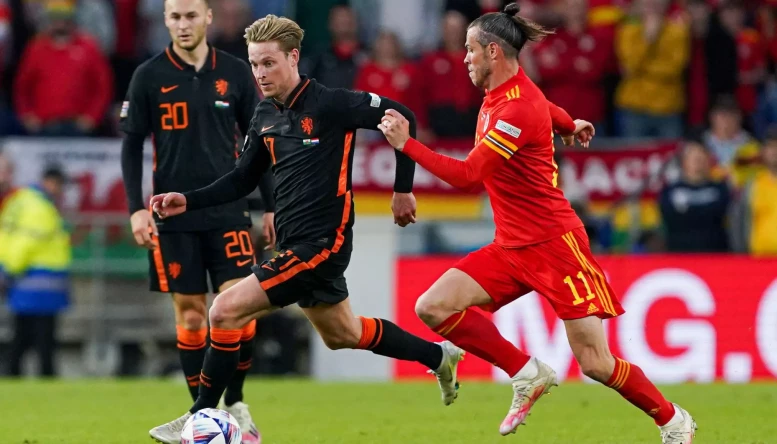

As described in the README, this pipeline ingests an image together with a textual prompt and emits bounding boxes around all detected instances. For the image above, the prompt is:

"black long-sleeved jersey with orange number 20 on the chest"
[121,46,268,231]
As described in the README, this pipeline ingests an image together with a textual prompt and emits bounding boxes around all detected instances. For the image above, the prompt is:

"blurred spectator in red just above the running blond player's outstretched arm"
[354,31,421,129]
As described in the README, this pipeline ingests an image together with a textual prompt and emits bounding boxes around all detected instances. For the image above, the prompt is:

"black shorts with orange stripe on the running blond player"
[252,235,353,308]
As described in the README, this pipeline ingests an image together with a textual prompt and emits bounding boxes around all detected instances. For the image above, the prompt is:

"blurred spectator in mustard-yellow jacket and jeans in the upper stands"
[615,0,690,138]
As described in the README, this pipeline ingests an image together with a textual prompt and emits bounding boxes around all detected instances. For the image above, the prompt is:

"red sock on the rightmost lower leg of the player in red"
[606,357,674,426]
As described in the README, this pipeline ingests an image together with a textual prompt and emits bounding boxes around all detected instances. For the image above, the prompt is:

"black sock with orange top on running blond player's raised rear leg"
[358,318,442,370]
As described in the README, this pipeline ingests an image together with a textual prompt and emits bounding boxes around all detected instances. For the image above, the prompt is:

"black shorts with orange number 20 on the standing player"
[149,226,256,295]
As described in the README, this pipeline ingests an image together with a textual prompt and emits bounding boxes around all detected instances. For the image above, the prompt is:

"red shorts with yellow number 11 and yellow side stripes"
[453,227,624,320]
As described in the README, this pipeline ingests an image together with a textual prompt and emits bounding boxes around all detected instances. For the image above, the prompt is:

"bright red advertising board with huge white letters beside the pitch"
[394,255,777,383]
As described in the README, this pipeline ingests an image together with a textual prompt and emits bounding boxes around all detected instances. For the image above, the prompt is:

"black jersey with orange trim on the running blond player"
[184,76,415,249]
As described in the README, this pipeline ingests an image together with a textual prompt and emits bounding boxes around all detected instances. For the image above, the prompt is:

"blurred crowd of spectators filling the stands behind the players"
[0,0,777,254]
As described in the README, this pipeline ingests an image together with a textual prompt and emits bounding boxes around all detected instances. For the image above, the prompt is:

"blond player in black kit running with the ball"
[150,15,463,443]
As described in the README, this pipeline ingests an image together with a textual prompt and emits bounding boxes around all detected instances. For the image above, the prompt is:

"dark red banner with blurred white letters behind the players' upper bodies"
[353,139,677,201]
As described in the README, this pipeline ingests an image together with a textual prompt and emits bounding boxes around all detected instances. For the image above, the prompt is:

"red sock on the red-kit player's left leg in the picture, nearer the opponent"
[434,310,529,377]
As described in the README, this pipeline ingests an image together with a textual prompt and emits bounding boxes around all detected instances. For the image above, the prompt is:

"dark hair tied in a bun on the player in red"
[467,3,554,58]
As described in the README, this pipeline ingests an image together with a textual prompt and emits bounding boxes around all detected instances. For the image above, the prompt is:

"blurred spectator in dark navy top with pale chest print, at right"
[659,141,731,253]
